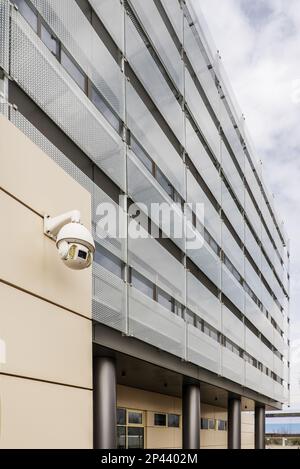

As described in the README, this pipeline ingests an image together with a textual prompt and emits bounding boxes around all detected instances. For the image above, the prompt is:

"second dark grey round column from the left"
[182,384,201,449]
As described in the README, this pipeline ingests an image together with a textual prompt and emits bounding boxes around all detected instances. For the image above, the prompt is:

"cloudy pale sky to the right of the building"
[197,0,300,409]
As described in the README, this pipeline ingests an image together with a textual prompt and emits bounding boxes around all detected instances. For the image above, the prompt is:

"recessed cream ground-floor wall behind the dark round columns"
[117,386,254,449]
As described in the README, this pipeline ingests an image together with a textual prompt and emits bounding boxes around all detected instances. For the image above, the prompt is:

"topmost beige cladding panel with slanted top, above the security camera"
[0,117,91,228]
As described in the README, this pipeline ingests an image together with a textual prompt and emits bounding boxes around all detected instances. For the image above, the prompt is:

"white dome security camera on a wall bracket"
[44,210,95,270]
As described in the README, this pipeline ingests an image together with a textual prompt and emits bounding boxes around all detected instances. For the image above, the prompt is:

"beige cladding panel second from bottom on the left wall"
[0,283,92,388]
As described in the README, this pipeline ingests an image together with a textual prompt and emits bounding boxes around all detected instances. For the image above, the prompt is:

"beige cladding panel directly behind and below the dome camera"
[0,190,92,317]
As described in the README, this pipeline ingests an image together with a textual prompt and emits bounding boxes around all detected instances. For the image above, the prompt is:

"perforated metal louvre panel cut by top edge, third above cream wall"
[32,0,124,117]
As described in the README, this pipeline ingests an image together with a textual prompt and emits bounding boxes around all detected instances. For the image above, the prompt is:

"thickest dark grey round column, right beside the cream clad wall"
[93,357,117,449]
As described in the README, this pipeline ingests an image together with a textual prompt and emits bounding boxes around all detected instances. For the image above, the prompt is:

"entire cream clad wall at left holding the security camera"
[0,118,93,448]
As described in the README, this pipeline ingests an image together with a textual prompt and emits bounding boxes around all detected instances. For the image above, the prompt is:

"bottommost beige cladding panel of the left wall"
[0,375,93,449]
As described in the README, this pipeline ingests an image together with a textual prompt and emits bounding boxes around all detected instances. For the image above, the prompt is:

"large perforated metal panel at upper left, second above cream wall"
[11,10,125,189]
